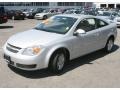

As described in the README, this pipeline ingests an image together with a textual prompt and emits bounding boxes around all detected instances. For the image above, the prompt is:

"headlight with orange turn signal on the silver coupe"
[22,46,41,56]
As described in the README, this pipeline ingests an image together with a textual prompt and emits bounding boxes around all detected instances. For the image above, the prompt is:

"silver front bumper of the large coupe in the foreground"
[3,47,46,70]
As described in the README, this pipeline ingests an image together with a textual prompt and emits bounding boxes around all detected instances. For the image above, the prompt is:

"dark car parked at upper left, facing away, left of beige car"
[7,10,26,20]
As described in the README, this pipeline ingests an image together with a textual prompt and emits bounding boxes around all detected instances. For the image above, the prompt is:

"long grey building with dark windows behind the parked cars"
[0,2,93,9]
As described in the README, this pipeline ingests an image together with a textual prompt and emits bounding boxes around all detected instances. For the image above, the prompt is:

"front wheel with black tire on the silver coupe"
[49,50,67,73]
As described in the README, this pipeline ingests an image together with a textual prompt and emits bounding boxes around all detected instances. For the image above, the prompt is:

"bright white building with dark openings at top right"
[94,2,120,9]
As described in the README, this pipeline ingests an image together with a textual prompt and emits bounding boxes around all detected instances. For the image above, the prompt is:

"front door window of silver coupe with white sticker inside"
[76,18,96,32]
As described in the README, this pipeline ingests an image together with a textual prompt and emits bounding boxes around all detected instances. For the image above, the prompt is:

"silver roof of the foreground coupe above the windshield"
[55,14,94,19]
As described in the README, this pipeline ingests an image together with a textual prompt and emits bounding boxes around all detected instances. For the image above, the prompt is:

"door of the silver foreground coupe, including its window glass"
[72,18,100,57]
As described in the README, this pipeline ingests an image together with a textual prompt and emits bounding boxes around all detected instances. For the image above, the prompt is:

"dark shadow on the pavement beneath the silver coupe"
[8,45,119,79]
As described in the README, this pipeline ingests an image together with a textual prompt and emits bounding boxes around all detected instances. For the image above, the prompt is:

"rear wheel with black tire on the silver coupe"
[104,37,114,53]
